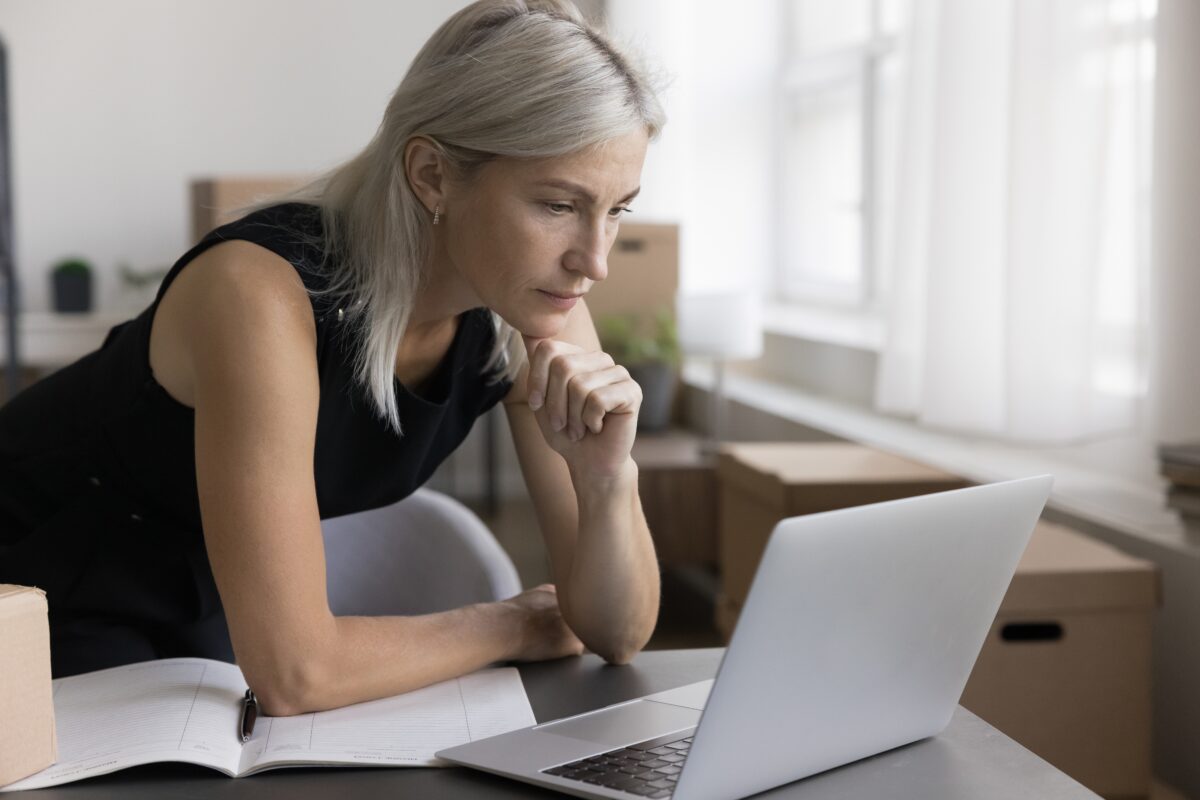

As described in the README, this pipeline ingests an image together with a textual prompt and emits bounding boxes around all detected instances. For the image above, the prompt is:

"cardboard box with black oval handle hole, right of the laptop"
[961,523,1159,798]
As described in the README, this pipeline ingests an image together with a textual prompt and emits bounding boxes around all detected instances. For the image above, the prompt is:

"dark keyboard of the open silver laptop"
[541,734,691,798]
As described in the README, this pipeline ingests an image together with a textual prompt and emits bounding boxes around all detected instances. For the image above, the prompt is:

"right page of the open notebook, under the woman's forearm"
[242,667,535,774]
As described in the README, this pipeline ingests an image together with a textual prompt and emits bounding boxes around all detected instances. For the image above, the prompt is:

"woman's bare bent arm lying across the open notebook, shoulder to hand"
[151,242,581,715]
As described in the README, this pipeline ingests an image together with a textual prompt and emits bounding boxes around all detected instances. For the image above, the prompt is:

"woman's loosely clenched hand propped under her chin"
[524,337,642,479]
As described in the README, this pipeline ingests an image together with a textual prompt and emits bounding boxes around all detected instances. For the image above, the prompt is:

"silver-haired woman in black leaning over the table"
[0,0,662,715]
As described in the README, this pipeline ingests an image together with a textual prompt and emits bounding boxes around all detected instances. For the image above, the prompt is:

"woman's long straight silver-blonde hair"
[262,0,665,433]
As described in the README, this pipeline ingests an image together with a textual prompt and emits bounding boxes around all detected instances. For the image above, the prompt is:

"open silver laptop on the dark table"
[438,476,1052,800]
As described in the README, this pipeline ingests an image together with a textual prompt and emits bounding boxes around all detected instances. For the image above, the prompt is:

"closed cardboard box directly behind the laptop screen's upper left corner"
[716,443,970,609]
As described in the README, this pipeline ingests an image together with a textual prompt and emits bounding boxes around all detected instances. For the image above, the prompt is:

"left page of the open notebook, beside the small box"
[2,658,246,792]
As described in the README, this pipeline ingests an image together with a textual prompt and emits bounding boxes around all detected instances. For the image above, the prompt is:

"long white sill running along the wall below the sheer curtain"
[683,360,1200,555]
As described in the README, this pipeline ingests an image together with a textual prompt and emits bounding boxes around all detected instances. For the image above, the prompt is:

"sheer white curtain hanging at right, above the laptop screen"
[877,0,1154,443]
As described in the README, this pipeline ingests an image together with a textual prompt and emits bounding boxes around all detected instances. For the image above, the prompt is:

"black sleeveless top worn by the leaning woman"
[0,203,511,671]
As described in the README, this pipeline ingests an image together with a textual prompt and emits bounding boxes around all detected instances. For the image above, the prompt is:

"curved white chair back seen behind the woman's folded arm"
[320,488,521,615]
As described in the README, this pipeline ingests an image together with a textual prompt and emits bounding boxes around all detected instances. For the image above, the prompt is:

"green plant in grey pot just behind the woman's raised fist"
[596,309,679,431]
